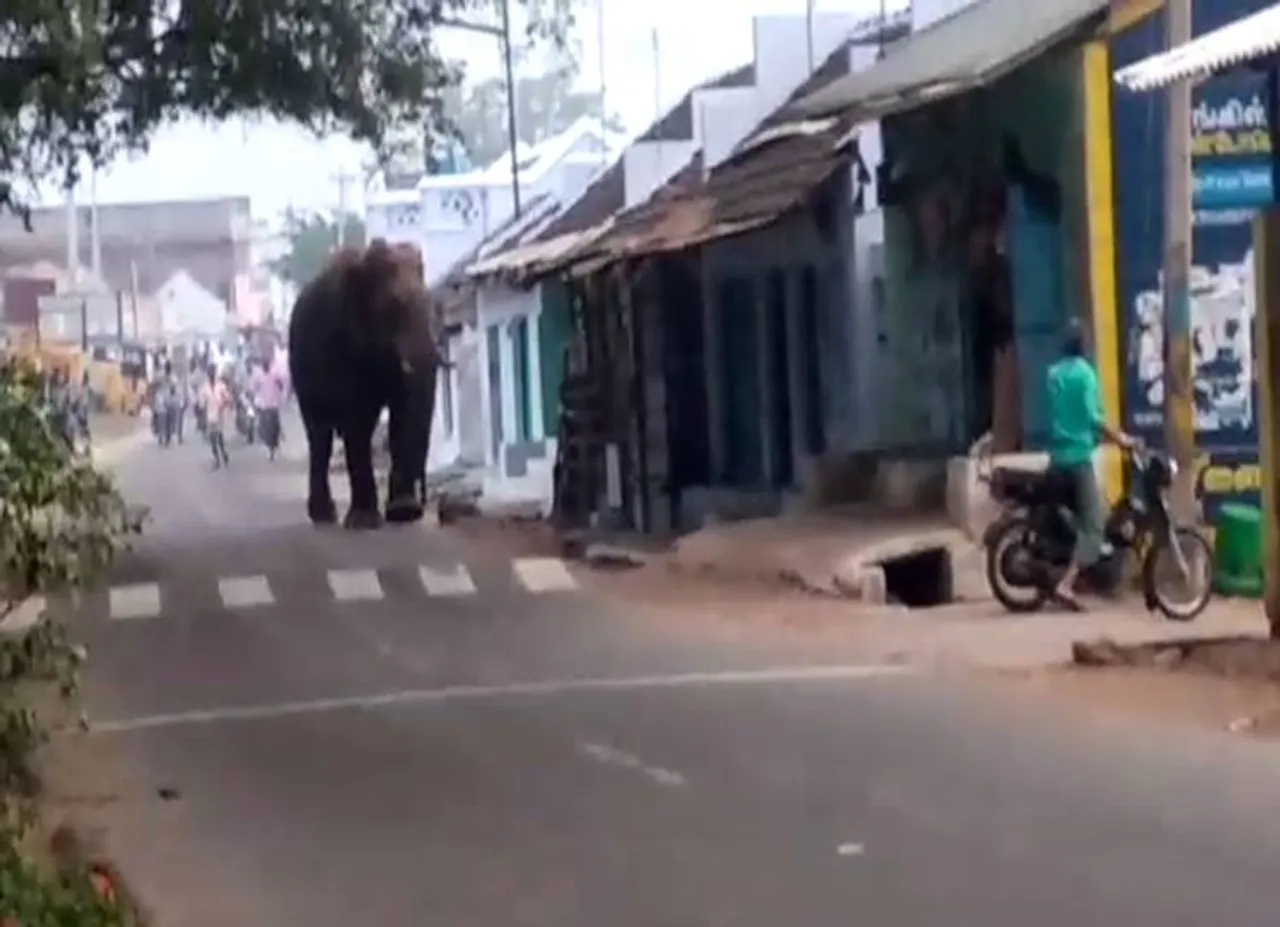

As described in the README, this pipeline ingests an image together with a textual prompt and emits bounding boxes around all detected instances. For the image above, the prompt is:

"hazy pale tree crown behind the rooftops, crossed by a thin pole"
[443,67,623,166]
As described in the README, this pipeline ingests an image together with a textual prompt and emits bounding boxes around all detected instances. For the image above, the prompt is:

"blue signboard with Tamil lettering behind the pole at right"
[1112,0,1272,512]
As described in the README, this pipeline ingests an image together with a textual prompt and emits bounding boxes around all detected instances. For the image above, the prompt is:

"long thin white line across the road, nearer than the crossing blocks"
[92,663,915,734]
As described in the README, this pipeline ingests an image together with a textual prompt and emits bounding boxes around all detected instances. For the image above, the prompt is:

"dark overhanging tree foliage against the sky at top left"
[0,0,572,218]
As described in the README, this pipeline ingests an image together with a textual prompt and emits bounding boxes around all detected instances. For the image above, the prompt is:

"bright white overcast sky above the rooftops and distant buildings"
[52,0,899,219]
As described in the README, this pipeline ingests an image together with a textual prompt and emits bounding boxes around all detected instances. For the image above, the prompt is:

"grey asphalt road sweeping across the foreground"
[57,414,1280,927]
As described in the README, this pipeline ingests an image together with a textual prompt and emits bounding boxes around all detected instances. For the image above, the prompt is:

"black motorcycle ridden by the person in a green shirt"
[983,449,1213,621]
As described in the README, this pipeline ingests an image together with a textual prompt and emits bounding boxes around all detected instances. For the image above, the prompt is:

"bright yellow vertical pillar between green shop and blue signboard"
[1080,38,1124,502]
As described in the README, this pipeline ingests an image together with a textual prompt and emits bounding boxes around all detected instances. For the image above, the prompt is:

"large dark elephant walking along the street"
[289,238,444,529]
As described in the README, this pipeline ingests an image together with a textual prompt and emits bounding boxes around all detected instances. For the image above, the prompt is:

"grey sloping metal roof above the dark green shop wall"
[792,0,1108,122]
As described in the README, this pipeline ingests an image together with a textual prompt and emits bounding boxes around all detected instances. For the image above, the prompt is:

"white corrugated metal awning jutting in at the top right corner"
[1116,4,1280,91]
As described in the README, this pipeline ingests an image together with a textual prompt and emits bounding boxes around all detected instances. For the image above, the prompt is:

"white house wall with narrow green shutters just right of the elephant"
[476,286,556,508]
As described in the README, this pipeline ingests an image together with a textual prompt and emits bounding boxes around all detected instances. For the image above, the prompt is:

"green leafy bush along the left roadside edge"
[0,361,138,927]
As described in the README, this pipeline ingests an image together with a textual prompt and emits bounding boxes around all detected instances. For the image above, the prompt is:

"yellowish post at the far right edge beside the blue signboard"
[1253,206,1280,638]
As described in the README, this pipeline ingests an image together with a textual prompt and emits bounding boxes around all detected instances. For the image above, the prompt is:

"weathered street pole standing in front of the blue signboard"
[1162,0,1197,522]
